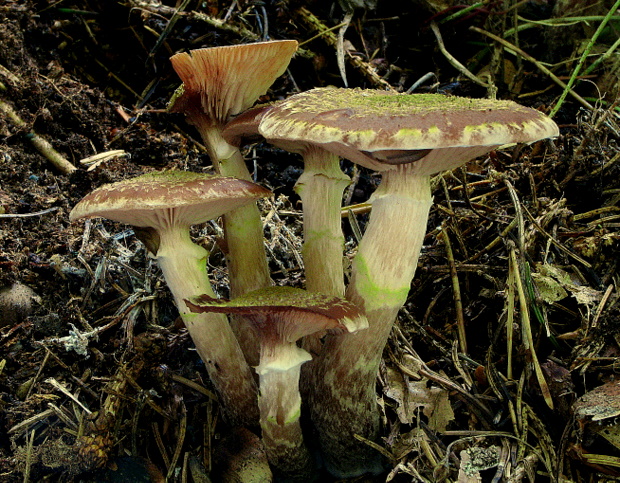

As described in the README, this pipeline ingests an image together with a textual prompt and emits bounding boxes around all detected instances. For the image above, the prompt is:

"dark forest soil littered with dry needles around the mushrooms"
[0,0,620,482]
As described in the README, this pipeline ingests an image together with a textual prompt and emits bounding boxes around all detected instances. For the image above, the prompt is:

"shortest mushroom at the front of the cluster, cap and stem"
[186,287,367,481]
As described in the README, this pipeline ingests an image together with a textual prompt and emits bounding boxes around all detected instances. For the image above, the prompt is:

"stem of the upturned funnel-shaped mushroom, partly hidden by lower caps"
[192,118,272,366]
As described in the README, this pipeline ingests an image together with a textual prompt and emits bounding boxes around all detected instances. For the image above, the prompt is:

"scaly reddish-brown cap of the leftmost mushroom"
[69,171,271,227]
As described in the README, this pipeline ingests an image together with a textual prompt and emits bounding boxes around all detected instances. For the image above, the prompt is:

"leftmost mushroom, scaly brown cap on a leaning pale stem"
[70,171,271,426]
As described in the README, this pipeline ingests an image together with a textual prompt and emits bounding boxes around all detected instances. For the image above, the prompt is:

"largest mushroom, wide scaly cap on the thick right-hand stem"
[236,88,558,477]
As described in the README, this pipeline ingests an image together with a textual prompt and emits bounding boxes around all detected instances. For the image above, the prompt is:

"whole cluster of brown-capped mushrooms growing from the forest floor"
[71,41,558,481]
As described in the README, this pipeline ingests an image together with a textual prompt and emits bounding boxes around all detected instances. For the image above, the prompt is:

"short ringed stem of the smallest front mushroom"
[257,342,314,482]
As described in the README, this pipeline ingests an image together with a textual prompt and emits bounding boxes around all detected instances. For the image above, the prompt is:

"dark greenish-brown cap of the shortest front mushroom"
[185,287,368,343]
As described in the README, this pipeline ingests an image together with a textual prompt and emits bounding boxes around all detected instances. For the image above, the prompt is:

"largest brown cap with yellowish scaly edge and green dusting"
[249,88,558,174]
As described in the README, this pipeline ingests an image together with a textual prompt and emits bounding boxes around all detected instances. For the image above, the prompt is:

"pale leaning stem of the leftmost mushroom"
[157,221,259,427]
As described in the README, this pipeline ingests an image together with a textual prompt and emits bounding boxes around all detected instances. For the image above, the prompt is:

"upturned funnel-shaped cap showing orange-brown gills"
[170,40,297,122]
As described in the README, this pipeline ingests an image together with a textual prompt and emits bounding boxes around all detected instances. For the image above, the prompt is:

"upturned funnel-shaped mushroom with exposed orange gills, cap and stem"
[169,40,297,363]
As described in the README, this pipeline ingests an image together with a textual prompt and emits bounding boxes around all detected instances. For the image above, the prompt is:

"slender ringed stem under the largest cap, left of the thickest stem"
[295,145,350,297]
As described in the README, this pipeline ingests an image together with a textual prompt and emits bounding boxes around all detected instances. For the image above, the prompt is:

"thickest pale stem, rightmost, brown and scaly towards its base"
[309,165,432,477]
